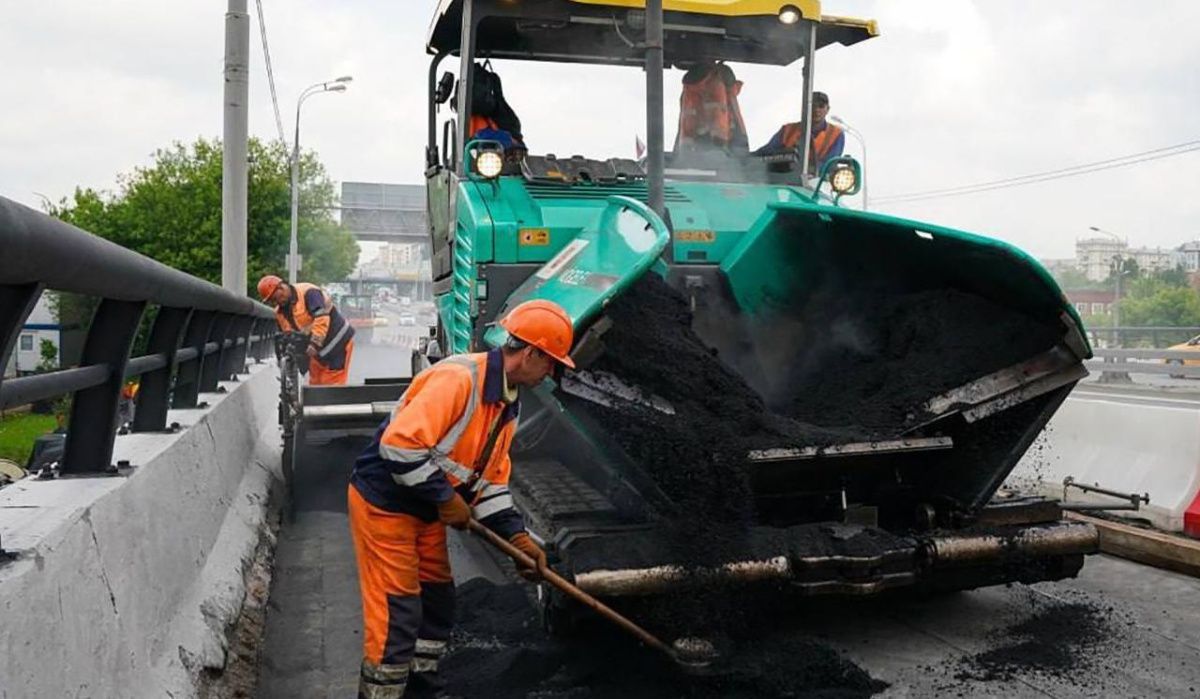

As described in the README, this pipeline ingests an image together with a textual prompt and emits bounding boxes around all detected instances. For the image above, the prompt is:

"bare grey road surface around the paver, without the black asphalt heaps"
[257,338,1200,699]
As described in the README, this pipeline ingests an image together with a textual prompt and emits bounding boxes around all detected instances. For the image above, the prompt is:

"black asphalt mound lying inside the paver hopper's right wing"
[772,288,1057,436]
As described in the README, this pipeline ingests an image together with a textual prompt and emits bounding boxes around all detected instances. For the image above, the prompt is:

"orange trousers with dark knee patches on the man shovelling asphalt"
[347,485,454,697]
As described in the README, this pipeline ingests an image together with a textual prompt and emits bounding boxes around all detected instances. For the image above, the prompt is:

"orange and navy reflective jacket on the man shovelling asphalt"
[350,350,524,538]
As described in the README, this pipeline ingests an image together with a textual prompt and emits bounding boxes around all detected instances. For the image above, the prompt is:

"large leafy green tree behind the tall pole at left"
[48,138,358,297]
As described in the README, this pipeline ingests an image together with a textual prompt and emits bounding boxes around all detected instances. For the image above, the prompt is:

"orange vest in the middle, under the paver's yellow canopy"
[677,65,746,148]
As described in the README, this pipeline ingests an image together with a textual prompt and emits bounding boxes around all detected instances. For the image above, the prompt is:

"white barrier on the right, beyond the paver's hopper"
[1010,384,1200,536]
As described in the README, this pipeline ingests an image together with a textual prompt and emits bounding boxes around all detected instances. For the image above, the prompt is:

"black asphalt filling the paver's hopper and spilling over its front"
[581,274,1055,564]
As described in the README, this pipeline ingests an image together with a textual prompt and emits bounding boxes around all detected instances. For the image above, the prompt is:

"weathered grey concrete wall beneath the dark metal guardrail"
[0,365,280,699]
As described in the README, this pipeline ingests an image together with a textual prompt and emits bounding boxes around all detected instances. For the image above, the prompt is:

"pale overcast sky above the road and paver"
[0,0,1200,257]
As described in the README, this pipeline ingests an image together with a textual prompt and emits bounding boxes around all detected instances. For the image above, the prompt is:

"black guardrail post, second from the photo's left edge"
[60,299,146,473]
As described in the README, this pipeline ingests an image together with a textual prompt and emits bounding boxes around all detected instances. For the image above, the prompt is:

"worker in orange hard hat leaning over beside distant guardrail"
[258,274,354,386]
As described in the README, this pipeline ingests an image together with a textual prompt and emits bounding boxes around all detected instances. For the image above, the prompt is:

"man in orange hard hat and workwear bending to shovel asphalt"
[347,300,575,699]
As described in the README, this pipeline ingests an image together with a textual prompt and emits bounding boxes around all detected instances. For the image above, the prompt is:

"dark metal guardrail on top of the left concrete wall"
[0,197,275,474]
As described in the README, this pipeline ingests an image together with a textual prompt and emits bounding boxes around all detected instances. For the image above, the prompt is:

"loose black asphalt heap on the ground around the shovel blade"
[442,579,886,699]
